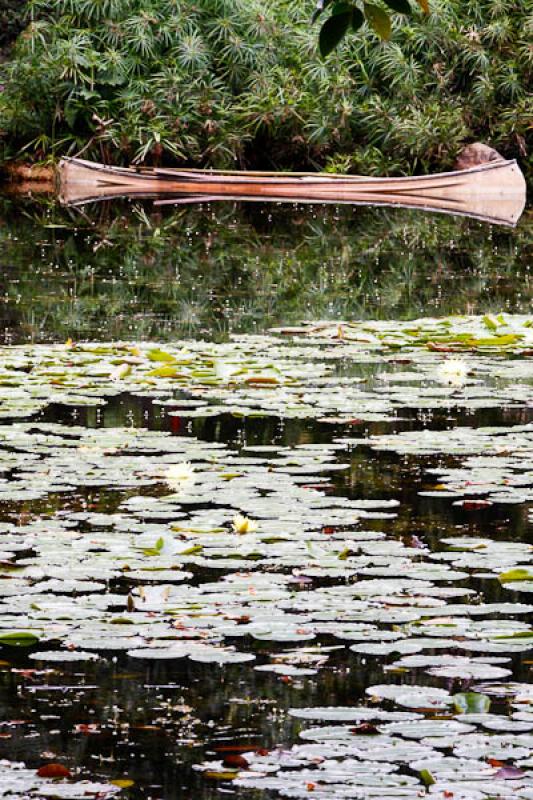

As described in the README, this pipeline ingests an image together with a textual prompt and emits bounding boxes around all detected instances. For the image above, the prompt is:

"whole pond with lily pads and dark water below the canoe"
[0,199,533,800]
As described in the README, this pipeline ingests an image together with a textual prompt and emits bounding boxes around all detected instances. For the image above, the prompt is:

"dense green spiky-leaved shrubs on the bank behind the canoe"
[0,0,533,174]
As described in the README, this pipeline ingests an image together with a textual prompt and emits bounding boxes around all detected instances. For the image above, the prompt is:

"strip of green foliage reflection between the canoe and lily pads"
[0,200,533,340]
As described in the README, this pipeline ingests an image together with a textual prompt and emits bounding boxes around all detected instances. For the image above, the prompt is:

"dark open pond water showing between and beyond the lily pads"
[0,195,533,800]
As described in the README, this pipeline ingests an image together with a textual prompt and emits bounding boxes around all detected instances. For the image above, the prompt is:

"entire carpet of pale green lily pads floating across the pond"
[0,310,533,800]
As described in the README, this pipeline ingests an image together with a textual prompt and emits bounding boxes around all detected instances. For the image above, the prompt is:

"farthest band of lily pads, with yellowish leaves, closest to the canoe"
[0,315,533,422]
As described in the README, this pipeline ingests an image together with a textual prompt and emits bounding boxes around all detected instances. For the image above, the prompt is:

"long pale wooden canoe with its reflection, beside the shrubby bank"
[59,158,526,225]
